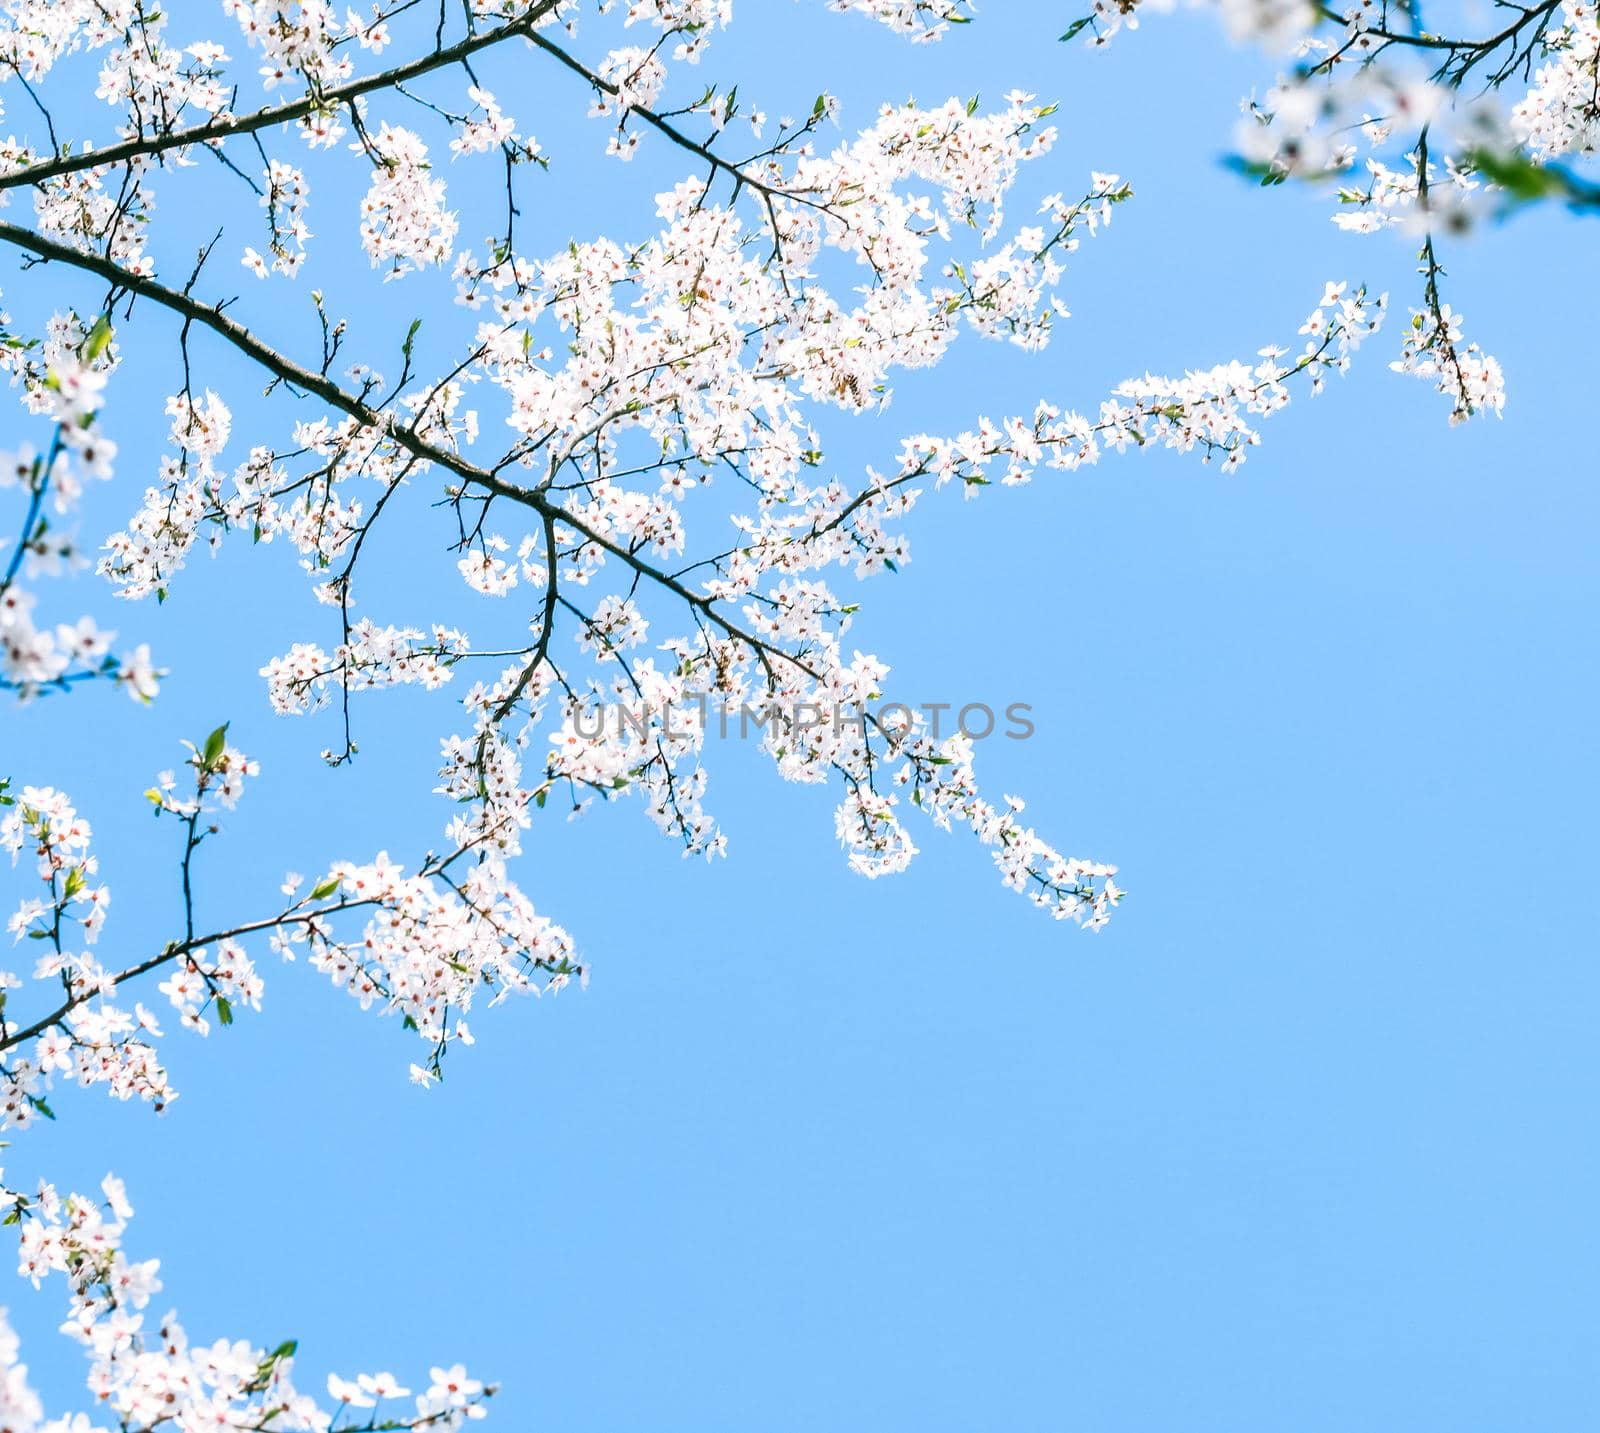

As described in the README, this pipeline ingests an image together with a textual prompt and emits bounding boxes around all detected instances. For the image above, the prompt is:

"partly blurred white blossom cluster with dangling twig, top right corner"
[1062,0,1600,422]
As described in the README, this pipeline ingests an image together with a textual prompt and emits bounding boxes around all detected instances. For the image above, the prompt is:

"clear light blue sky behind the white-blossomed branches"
[0,0,1600,1433]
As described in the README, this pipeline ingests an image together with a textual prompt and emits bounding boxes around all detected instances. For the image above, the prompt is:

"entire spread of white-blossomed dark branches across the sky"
[0,0,1561,1433]
